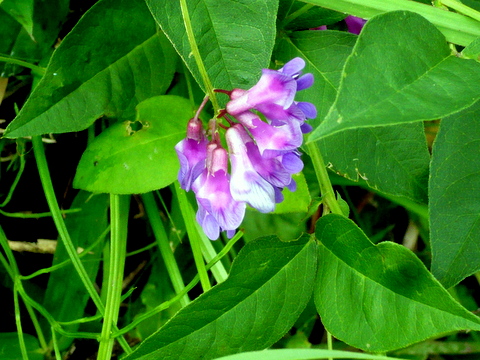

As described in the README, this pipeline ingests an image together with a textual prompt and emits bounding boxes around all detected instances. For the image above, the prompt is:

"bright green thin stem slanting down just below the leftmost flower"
[173,181,212,292]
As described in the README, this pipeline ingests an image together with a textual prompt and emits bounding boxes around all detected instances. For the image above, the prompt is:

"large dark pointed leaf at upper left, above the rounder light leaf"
[6,0,175,138]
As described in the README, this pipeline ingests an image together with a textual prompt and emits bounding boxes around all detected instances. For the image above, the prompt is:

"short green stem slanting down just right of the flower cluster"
[307,143,343,215]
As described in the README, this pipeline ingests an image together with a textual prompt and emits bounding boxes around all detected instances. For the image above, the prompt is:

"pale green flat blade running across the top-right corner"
[302,0,480,46]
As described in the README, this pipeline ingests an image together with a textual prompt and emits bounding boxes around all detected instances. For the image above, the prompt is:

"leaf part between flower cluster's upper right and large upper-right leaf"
[274,30,357,127]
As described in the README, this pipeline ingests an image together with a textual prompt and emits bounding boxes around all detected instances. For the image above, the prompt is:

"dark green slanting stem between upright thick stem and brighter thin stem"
[142,192,190,307]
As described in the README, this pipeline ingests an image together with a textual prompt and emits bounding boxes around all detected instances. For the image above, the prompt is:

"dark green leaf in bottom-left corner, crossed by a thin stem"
[0,333,44,360]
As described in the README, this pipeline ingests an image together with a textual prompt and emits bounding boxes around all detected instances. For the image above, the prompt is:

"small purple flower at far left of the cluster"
[175,118,208,191]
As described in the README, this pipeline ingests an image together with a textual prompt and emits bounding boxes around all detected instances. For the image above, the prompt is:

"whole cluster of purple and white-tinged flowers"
[175,58,317,240]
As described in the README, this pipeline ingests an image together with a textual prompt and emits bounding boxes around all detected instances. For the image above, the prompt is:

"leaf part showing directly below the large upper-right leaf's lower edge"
[318,123,430,203]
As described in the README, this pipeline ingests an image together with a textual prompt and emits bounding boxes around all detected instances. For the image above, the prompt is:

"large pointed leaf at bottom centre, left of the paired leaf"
[125,236,316,360]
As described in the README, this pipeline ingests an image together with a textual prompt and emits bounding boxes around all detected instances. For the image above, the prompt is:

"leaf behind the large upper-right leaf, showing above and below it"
[275,31,430,202]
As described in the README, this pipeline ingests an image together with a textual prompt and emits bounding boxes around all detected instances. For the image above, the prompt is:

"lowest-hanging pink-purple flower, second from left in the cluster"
[193,142,245,240]
